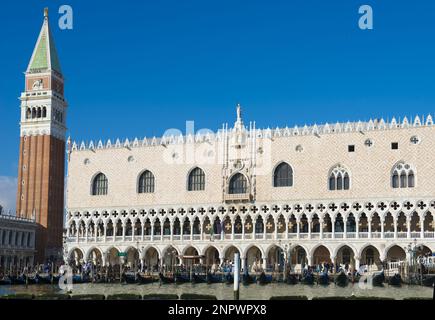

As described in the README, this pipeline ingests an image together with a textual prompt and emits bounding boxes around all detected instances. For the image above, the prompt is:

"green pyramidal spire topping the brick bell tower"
[27,8,62,73]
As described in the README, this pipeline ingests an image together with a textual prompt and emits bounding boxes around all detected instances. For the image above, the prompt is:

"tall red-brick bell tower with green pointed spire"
[17,8,67,263]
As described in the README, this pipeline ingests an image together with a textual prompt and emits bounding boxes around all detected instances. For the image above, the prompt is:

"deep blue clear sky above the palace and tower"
[0,0,435,209]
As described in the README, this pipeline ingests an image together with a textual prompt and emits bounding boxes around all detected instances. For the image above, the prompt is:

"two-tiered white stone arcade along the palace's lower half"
[66,199,435,270]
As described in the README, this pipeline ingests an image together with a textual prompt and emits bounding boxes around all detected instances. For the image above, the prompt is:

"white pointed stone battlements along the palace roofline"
[68,114,434,152]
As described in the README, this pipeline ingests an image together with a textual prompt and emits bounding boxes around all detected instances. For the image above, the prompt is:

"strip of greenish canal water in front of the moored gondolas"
[0,283,433,300]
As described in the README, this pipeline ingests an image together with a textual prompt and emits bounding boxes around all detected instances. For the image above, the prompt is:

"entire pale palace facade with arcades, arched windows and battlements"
[65,106,435,268]
